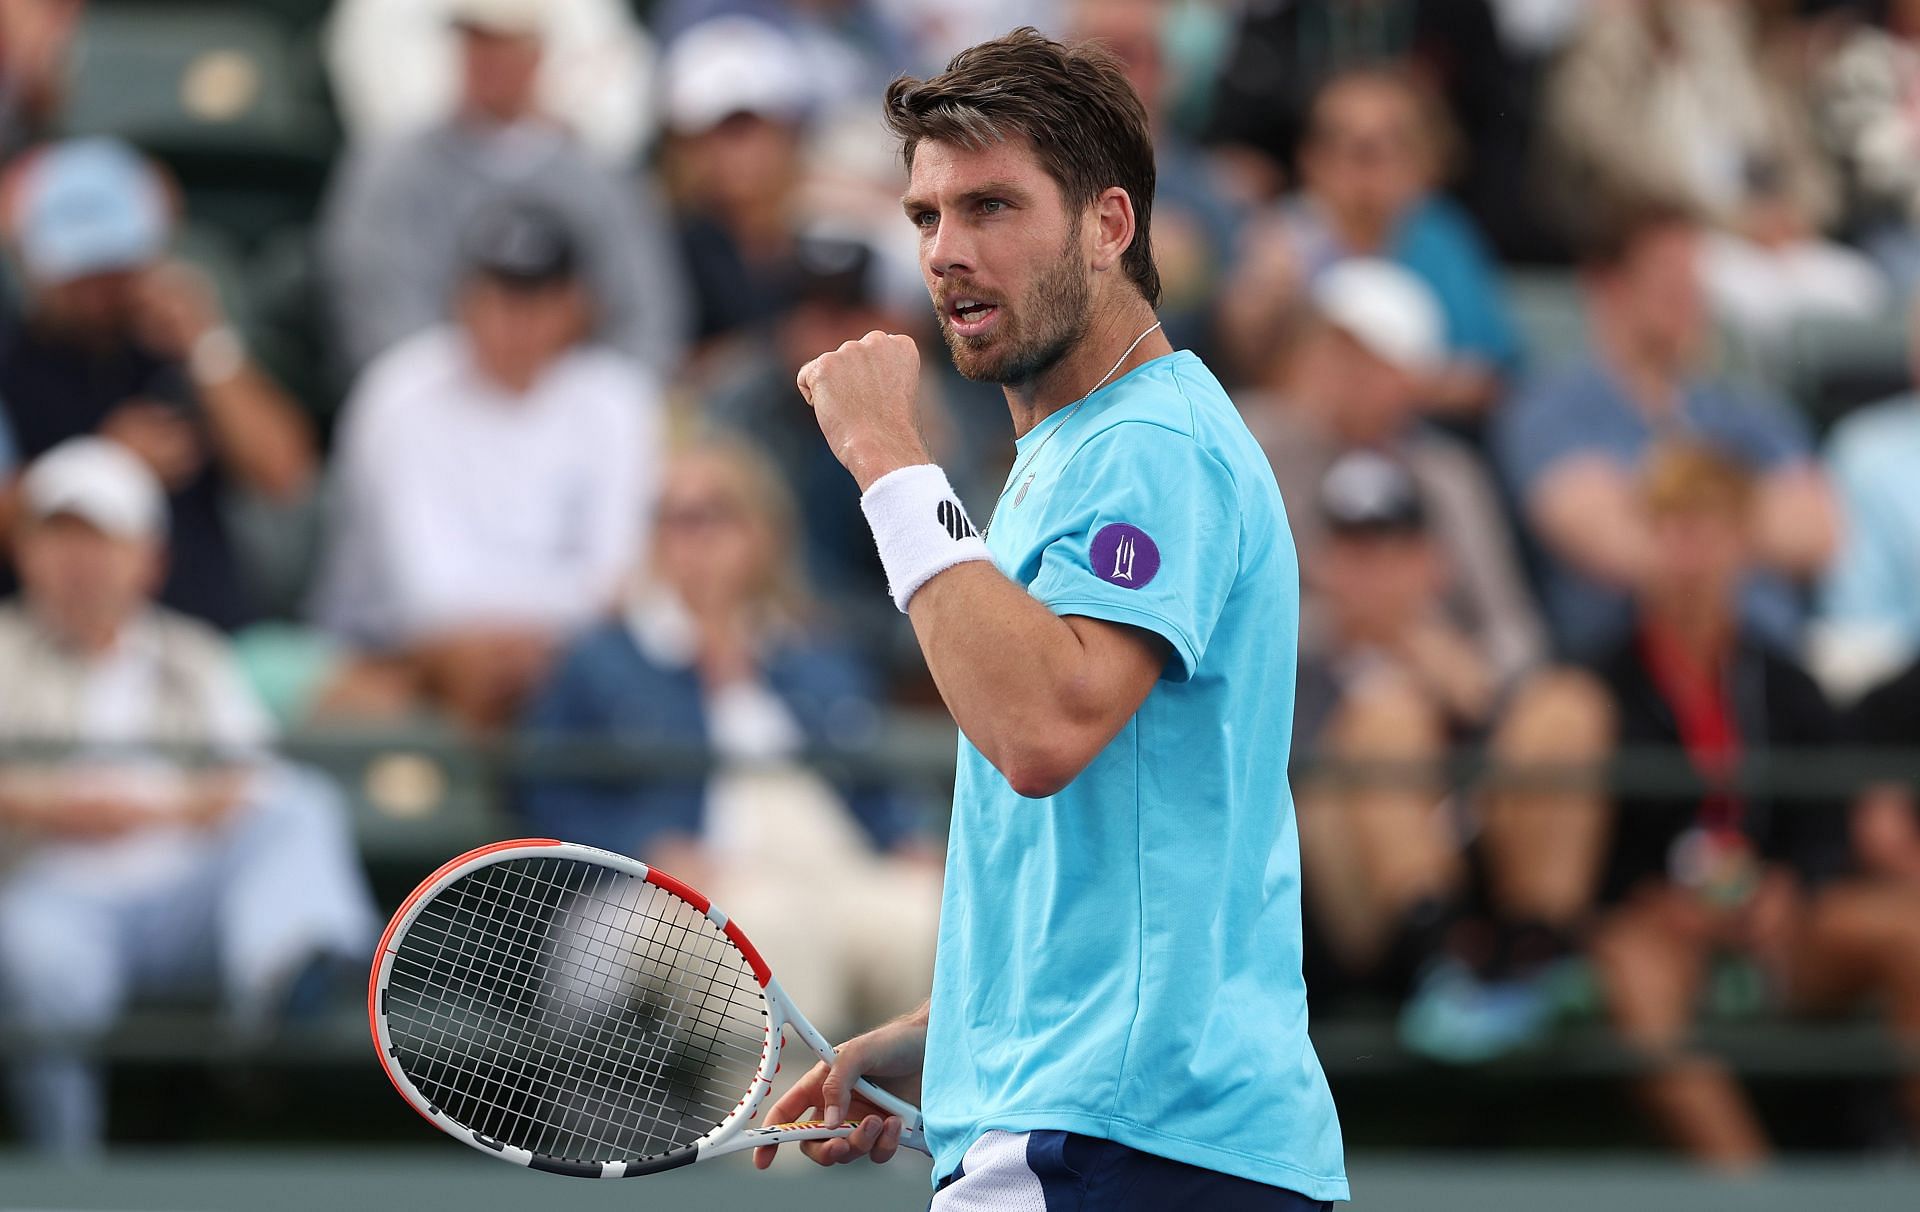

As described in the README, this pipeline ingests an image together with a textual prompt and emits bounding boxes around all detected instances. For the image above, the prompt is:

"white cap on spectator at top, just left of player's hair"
[666,17,818,134]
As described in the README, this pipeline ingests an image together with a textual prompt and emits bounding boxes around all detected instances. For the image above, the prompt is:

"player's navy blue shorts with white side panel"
[929,1129,1332,1212]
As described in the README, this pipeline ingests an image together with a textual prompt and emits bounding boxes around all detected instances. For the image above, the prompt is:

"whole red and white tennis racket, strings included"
[367,837,927,1177]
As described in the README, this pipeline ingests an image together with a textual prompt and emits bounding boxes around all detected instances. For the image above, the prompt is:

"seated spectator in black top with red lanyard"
[1594,446,1920,1168]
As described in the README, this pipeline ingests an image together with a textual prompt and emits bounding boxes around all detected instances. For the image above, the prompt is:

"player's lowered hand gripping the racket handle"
[753,1006,927,1170]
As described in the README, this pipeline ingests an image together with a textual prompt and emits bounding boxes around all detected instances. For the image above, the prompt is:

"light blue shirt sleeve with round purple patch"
[1027,423,1240,682]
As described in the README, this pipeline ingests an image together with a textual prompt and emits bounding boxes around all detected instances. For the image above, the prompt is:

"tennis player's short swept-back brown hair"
[885,27,1160,303]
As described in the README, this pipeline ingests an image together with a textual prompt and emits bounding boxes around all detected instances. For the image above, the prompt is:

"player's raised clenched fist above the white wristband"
[797,332,933,492]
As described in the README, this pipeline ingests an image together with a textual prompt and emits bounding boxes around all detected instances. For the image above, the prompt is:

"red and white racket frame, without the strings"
[367,837,927,1177]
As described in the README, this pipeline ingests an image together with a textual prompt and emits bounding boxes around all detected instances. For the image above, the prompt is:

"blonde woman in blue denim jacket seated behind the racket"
[526,442,939,1031]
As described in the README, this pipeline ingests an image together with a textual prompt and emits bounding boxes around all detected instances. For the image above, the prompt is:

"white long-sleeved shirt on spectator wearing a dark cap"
[317,328,662,645]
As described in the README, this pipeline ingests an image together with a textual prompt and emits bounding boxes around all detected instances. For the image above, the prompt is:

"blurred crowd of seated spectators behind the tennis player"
[0,0,1920,1166]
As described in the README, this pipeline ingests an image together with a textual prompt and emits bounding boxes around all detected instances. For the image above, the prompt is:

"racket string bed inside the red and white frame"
[384,859,766,1162]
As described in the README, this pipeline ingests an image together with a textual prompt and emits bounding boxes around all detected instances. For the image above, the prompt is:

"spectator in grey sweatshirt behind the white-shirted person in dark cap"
[319,0,685,378]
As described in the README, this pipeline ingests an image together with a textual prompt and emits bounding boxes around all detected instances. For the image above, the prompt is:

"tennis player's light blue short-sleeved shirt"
[924,353,1348,1199]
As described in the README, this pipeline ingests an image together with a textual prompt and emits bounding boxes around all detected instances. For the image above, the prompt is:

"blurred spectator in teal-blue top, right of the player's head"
[1223,71,1519,415]
